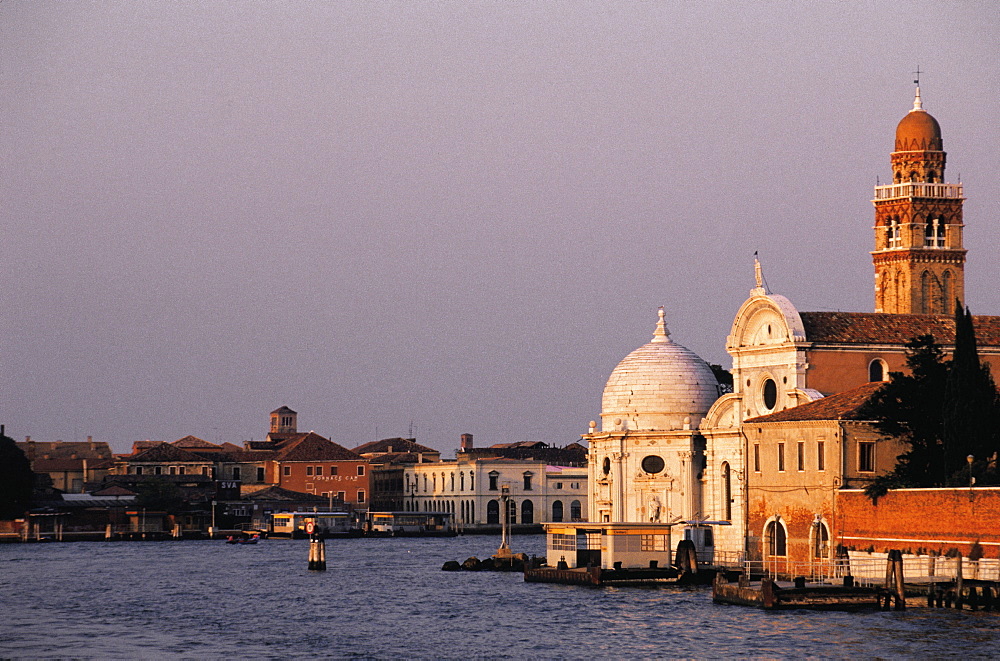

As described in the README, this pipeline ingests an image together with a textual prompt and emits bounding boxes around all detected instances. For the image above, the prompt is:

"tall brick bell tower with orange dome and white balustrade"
[872,87,966,314]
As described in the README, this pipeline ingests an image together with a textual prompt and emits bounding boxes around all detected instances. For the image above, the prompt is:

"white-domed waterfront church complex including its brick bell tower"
[549,87,1000,567]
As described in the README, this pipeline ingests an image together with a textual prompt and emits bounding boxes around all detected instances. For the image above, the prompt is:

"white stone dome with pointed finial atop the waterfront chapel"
[601,308,719,431]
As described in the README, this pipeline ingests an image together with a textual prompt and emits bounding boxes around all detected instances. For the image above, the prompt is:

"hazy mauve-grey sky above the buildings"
[0,0,1000,456]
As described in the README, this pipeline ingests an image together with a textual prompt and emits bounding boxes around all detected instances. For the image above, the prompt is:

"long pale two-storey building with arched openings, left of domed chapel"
[403,455,587,529]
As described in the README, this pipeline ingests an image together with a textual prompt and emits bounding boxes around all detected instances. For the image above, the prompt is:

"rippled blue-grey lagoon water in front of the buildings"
[0,536,1000,659]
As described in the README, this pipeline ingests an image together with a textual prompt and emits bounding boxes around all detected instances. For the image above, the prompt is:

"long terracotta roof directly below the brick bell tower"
[799,312,1000,347]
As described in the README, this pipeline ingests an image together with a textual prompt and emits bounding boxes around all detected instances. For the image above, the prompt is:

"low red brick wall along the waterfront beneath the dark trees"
[836,487,1000,558]
